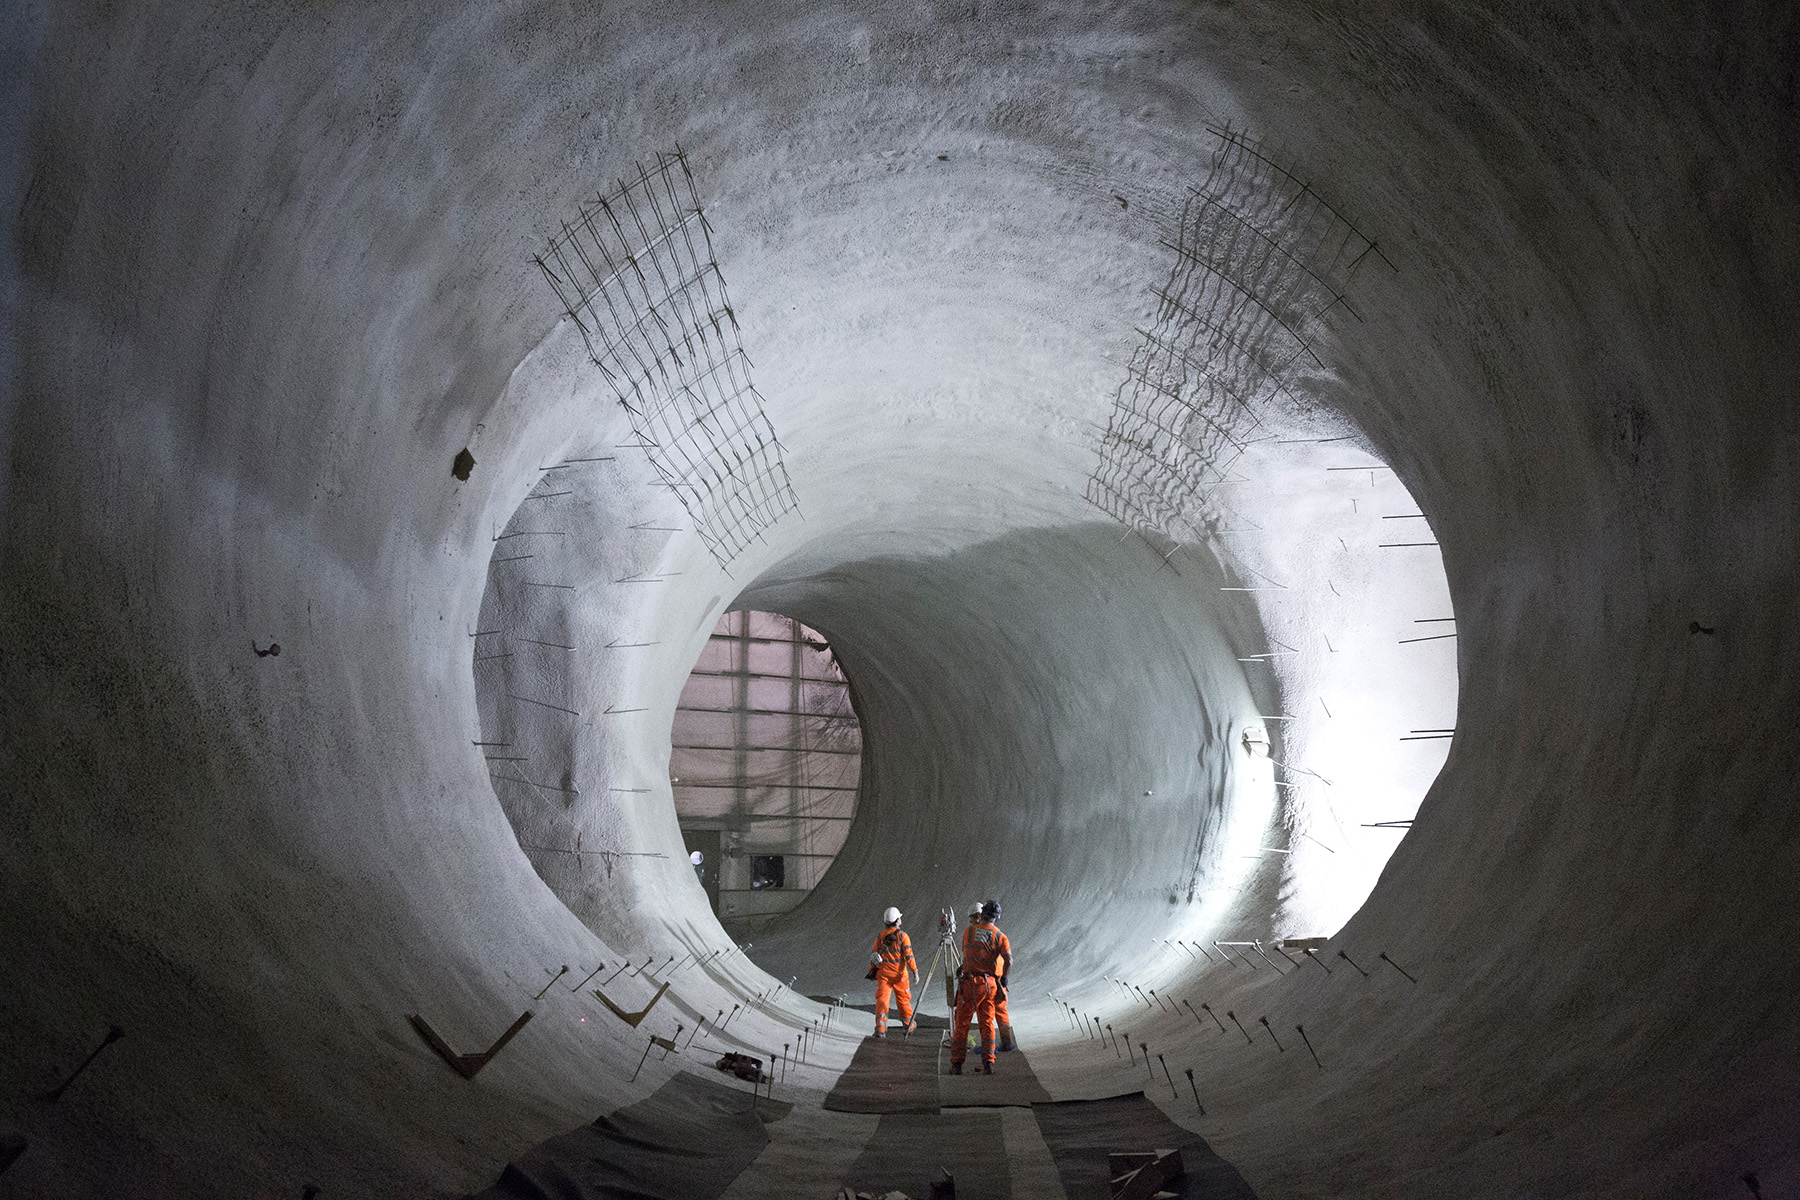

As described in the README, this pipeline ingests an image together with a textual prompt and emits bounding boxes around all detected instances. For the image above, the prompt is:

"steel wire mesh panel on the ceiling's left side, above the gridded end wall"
[535,148,799,567]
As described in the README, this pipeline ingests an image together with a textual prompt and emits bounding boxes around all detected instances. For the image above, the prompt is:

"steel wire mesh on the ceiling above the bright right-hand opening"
[1085,130,1391,540]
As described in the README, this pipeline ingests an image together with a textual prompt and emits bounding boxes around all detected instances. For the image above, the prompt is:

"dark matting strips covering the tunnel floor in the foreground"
[477,1029,1255,1200]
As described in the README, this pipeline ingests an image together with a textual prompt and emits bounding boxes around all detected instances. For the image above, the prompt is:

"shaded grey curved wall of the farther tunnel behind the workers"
[740,522,1276,995]
